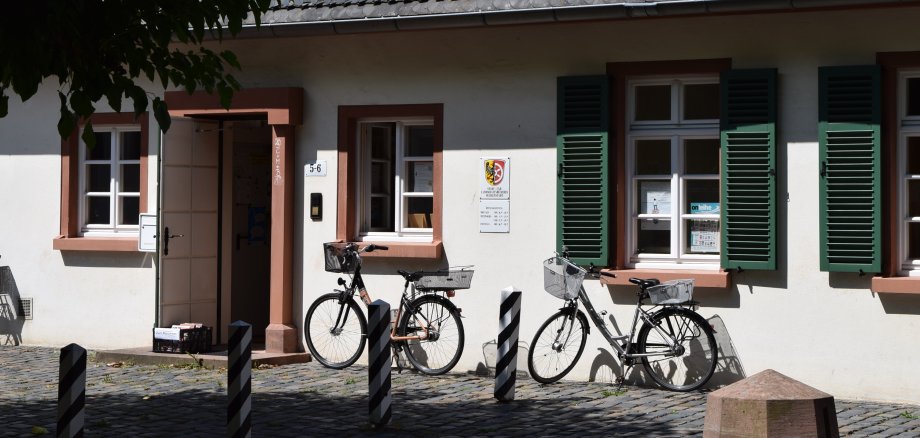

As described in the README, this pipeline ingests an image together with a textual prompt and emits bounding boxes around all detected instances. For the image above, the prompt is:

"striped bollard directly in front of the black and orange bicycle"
[367,300,393,426]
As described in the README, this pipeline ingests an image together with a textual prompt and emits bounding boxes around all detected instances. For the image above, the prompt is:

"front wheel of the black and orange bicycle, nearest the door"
[303,292,367,369]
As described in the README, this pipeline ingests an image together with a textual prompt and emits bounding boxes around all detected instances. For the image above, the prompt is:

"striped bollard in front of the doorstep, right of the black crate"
[227,321,252,437]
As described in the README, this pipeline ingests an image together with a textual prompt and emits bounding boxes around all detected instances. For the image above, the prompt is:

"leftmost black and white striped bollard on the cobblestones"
[57,344,86,438]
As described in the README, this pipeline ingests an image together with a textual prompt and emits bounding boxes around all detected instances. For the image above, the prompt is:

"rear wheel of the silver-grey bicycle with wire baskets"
[636,307,719,391]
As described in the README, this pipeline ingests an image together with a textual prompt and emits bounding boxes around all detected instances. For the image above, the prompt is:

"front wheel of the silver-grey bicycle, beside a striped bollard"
[527,310,588,383]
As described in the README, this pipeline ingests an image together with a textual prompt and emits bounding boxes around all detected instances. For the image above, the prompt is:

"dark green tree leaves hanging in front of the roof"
[0,0,270,137]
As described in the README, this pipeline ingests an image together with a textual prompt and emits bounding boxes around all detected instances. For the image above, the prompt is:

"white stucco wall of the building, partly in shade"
[0,8,920,403]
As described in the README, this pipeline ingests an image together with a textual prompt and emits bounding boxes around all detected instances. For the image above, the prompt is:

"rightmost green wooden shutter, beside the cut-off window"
[818,65,882,272]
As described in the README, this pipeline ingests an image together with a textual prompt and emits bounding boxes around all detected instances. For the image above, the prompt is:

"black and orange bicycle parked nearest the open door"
[304,243,473,375]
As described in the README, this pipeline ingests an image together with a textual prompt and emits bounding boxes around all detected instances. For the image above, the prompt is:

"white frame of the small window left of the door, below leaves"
[78,125,144,236]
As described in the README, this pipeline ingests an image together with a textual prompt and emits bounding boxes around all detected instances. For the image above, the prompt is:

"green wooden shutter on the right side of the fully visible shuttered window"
[720,69,776,270]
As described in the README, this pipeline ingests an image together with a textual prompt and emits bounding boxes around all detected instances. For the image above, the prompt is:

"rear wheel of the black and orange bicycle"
[396,295,463,376]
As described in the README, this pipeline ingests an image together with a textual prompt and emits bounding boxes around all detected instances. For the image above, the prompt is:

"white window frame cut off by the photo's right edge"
[897,69,920,277]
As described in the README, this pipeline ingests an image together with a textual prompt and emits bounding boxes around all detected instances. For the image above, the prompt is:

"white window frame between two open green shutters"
[625,75,721,270]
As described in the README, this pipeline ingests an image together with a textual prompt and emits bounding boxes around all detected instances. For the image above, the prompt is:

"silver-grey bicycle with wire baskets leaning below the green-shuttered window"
[527,249,718,391]
